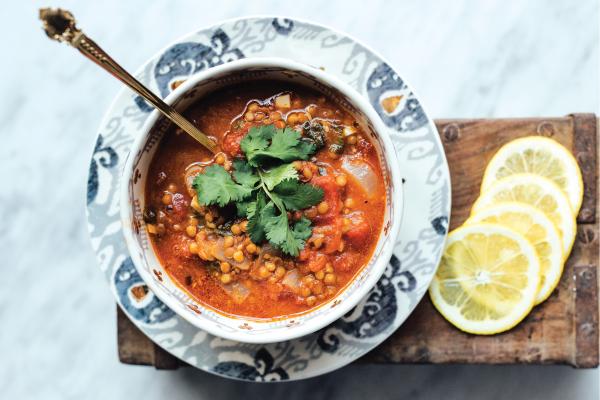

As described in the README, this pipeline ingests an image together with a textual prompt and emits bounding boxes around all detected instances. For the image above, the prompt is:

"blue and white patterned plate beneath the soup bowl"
[87,17,451,381]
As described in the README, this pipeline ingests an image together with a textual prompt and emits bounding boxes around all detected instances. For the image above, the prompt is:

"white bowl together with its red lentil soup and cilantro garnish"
[121,59,402,343]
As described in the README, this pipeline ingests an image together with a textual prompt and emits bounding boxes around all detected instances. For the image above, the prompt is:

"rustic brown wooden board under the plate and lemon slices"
[117,114,600,369]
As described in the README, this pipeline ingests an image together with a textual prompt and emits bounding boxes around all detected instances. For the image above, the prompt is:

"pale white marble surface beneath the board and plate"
[0,0,599,400]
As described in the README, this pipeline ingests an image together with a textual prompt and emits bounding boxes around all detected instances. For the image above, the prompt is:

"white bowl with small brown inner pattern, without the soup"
[120,58,403,343]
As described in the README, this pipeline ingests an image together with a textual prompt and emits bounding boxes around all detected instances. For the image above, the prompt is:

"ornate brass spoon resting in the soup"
[40,8,217,153]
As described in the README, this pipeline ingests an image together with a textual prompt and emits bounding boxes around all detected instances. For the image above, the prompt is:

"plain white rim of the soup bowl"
[119,57,404,344]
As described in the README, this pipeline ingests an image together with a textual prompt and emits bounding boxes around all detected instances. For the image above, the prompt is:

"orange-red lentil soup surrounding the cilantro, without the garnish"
[144,81,386,318]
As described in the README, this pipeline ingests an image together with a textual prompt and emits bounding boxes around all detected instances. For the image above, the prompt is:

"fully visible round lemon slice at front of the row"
[429,224,540,335]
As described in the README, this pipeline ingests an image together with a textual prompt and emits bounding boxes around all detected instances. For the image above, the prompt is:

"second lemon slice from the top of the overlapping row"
[471,174,577,257]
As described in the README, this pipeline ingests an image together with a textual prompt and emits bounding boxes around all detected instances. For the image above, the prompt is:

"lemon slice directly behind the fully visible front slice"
[465,203,564,304]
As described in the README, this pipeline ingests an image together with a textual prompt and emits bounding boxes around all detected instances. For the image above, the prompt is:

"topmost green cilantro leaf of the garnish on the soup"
[241,125,316,166]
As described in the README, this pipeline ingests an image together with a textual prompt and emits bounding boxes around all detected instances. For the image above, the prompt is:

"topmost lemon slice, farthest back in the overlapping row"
[481,136,583,215]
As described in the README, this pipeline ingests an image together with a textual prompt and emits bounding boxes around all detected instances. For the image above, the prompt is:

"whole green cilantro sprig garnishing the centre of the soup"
[193,125,323,257]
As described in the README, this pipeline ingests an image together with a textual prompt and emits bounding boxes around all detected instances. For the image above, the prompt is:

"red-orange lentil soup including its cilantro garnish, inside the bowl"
[144,81,386,318]
